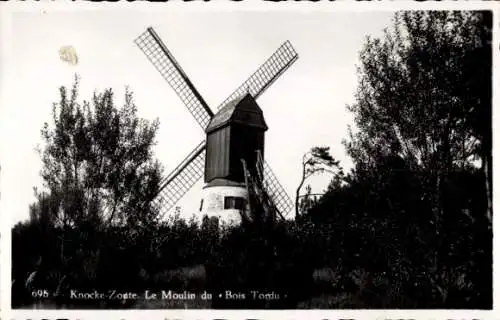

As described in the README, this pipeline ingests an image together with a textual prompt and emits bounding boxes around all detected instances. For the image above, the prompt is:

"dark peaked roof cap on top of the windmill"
[205,93,267,133]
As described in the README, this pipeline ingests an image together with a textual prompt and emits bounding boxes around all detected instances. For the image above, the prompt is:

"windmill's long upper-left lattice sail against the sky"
[134,28,213,130]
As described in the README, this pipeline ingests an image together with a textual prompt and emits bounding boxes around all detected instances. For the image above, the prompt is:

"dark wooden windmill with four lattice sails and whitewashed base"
[134,27,298,222]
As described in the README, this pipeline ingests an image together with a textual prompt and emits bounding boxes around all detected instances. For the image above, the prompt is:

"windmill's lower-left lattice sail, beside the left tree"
[153,140,206,220]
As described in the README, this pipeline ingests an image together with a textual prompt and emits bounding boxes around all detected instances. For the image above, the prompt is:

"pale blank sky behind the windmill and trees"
[0,8,393,223]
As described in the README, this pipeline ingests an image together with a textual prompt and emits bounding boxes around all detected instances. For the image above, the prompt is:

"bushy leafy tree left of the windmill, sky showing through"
[31,77,161,227]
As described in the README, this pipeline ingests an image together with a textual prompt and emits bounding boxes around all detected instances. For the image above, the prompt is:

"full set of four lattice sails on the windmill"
[134,28,298,219]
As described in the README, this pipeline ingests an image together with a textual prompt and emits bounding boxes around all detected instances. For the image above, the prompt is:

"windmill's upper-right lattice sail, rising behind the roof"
[218,41,299,109]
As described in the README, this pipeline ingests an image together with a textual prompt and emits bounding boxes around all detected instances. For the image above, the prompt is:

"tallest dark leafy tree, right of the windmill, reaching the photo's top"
[345,11,491,225]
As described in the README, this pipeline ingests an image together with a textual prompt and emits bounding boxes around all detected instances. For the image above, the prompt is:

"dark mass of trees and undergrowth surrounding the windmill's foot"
[12,11,492,309]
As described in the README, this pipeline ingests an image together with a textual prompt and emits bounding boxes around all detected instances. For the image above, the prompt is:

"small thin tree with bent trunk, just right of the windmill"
[295,147,342,218]
